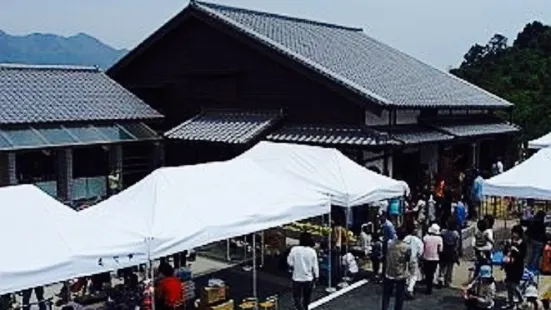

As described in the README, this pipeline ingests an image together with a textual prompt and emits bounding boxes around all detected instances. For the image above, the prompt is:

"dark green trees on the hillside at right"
[450,21,551,141]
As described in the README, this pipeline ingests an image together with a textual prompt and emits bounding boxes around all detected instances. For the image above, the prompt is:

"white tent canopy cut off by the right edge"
[482,148,551,200]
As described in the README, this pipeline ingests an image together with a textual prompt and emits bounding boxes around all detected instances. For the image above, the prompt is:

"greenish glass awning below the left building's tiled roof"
[0,123,161,151]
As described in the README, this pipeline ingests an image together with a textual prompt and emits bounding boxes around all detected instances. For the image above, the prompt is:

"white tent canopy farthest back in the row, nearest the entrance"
[236,142,409,207]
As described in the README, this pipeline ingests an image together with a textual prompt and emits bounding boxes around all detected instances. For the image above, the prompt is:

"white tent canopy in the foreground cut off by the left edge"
[0,185,147,294]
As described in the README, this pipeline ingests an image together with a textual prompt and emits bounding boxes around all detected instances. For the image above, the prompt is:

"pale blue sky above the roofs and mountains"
[0,0,551,69]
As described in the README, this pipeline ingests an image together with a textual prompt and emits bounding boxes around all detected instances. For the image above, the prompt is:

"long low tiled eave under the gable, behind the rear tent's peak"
[266,125,396,146]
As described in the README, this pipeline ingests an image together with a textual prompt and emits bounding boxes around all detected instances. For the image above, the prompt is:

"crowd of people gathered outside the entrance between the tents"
[289,161,551,310]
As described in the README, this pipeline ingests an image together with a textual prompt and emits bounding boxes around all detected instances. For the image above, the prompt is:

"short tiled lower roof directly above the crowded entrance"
[384,125,454,144]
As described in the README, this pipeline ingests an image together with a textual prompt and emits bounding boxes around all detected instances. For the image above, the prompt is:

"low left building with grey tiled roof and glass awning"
[0,64,162,204]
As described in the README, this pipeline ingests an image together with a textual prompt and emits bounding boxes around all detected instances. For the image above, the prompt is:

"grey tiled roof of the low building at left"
[0,64,162,125]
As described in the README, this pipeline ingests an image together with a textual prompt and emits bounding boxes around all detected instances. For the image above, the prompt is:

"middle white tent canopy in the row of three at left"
[81,161,330,258]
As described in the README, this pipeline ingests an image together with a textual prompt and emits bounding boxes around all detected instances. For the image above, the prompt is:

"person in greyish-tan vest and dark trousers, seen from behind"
[382,227,411,310]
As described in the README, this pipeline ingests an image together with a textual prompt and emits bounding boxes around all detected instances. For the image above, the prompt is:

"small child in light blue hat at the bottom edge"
[465,265,496,310]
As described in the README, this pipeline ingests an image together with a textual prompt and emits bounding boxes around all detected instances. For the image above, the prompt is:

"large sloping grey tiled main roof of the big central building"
[188,1,511,108]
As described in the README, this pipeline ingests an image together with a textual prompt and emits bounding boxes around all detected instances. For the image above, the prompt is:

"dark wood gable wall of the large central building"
[112,17,364,129]
